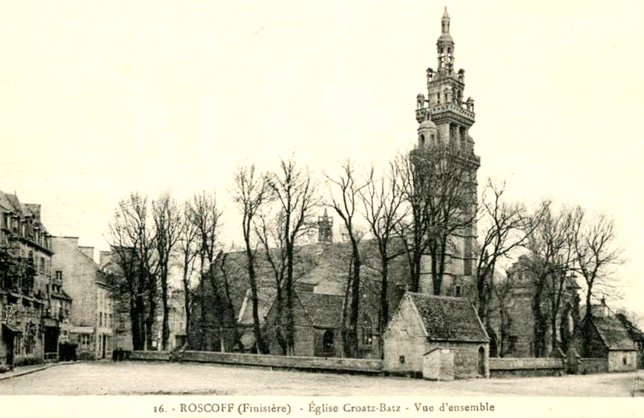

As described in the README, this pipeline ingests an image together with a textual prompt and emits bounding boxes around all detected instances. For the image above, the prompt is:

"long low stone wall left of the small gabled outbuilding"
[130,350,383,373]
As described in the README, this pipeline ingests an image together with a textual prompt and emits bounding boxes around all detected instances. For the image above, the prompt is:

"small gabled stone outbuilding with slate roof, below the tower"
[384,292,489,380]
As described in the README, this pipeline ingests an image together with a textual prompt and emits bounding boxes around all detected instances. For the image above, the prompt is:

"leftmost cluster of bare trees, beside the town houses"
[109,192,222,350]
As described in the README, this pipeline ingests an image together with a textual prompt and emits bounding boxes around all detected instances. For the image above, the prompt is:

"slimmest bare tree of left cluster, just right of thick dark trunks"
[178,202,199,342]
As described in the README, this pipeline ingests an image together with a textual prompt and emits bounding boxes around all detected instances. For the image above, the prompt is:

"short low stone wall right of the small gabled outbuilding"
[490,358,565,377]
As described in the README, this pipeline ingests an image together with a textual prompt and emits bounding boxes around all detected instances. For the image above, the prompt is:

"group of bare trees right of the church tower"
[476,188,624,357]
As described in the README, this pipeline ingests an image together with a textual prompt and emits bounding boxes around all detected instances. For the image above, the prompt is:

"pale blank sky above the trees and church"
[0,0,644,313]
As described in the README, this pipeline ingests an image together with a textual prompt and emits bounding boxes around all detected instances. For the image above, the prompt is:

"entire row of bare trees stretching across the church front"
[110,148,620,357]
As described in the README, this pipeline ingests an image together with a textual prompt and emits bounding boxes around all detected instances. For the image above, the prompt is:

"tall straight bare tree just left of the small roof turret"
[268,156,319,355]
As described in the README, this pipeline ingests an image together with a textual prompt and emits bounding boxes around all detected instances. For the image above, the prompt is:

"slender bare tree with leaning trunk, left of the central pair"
[234,165,271,353]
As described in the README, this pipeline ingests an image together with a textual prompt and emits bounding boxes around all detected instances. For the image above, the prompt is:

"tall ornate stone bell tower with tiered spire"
[412,8,481,296]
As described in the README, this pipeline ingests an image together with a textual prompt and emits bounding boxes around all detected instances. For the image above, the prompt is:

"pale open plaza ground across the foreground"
[0,362,638,397]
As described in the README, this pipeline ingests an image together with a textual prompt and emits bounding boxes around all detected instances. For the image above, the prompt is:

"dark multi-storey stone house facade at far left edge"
[0,192,62,365]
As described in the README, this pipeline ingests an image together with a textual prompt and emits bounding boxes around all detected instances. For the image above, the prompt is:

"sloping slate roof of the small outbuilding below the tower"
[406,292,489,342]
